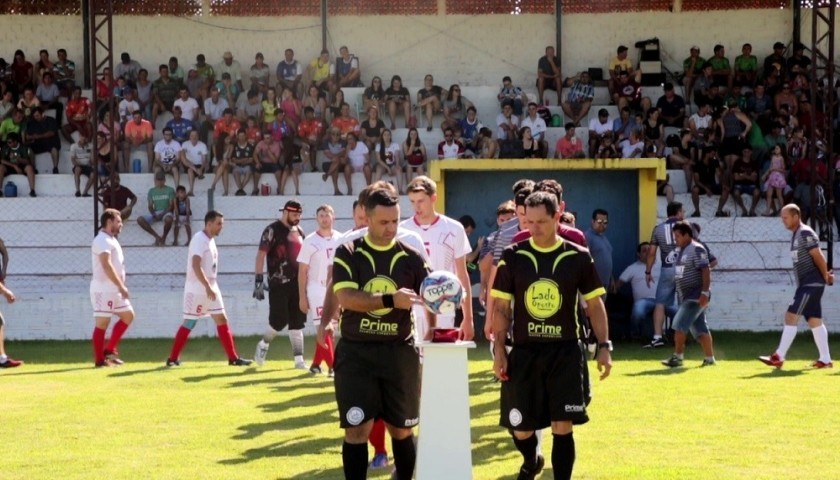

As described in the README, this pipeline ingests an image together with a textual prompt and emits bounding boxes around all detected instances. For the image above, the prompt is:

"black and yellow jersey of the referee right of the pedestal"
[491,239,606,345]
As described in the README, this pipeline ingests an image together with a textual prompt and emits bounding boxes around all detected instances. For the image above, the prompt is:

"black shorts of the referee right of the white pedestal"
[499,342,589,431]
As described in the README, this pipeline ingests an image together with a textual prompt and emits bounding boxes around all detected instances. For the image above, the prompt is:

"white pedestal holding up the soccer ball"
[417,342,475,480]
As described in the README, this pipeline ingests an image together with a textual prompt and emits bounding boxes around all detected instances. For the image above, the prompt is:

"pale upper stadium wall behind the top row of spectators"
[0,9,810,90]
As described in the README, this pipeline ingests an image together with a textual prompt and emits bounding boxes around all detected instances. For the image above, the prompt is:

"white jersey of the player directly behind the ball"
[400,215,472,273]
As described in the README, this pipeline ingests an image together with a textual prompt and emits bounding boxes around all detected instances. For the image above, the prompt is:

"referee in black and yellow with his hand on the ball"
[333,189,429,480]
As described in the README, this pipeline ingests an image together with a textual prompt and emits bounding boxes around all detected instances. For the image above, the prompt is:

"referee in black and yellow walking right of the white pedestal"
[491,192,612,480]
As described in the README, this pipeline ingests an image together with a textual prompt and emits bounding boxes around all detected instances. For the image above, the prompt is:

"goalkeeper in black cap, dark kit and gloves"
[254,200,307,370]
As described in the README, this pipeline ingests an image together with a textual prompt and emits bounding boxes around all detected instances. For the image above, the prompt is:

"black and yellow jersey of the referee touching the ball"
[333,235,429,342]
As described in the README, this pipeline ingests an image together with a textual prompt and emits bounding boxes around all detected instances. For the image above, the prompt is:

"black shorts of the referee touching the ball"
[335,339,420,428]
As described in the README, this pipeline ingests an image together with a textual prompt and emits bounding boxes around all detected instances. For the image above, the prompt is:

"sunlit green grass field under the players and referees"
[0,333,840,480]
